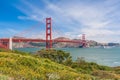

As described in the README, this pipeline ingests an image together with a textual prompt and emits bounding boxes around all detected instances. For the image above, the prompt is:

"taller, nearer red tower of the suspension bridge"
[46,18,52,49]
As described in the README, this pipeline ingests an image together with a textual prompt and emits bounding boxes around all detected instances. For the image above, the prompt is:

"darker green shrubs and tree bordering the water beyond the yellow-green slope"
[36,49,120,80]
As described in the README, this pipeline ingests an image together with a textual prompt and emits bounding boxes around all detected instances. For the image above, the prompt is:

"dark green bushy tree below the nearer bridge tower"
[36,49,72,63]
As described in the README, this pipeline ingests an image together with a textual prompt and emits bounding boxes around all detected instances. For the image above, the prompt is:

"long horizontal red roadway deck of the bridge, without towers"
[0,38,82,43]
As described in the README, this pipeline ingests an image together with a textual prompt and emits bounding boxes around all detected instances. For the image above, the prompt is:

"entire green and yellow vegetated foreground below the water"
[0,49,120,80]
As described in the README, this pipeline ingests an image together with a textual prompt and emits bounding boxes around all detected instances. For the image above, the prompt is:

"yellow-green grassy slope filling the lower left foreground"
[0,52,92,80]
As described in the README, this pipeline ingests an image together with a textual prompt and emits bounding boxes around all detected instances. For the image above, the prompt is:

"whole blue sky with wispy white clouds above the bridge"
[0,0,120,42]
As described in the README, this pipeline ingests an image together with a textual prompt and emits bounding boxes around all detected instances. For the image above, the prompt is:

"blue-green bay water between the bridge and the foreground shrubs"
[14,47,120,67]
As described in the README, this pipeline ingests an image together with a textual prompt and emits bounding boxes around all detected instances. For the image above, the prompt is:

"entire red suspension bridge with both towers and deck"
[0,18,87,49]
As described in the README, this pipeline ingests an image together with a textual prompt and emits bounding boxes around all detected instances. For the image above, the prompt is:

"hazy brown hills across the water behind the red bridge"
[13,36,120,48]
